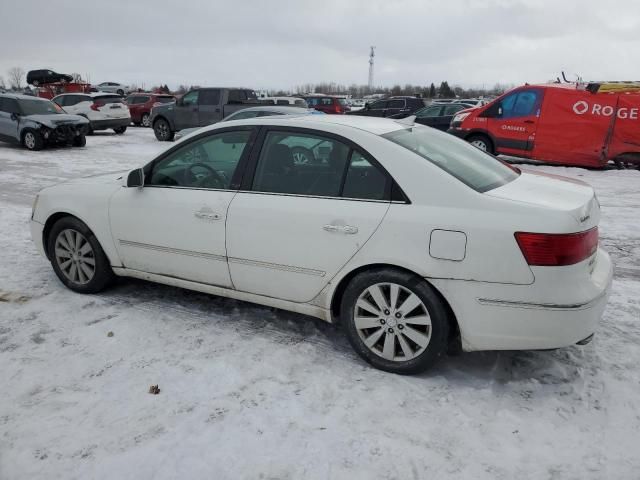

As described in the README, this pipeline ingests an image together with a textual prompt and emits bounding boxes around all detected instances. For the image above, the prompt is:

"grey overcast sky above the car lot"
[0,0,640,89]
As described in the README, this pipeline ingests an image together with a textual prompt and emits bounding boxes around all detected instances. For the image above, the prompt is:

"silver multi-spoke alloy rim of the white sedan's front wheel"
[54,228,96,285]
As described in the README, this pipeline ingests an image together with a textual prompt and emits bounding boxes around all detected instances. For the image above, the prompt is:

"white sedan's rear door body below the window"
[227,192,390,302]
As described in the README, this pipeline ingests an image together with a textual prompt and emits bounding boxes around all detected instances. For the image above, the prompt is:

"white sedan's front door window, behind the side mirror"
[145,130,251,190]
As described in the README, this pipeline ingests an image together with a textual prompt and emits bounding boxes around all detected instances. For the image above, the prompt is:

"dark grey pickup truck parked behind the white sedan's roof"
[150,88,260,142]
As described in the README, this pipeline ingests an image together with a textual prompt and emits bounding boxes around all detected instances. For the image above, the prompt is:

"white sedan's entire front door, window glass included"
[109,129,253,288]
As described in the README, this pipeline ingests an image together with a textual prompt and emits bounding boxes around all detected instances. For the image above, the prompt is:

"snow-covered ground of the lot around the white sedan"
[0,128,640,480]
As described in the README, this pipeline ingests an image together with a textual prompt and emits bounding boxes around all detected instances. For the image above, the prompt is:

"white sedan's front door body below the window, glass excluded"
[109,187,235,288]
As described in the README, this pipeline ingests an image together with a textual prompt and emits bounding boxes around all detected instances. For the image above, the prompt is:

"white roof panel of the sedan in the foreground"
[214,112,407,135]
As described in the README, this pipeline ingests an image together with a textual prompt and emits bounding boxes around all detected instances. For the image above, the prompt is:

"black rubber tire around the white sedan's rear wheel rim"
[340,268,449,375]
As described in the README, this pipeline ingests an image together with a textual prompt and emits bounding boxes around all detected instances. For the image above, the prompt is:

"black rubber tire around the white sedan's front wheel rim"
[46,216,115,293]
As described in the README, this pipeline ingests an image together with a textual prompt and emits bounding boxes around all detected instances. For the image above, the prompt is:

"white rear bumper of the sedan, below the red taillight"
[430,249,613,351]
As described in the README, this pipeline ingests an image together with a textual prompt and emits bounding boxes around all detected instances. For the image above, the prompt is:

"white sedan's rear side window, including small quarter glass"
[252,132,390,200]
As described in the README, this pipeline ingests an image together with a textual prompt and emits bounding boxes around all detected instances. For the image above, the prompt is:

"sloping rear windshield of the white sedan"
[382,126,519,192]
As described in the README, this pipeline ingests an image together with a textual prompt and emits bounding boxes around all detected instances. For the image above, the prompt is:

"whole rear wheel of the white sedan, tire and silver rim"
[340,268,449,374]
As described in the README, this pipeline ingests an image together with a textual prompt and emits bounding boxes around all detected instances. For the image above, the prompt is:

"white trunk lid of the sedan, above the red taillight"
[485,170,600,231]
